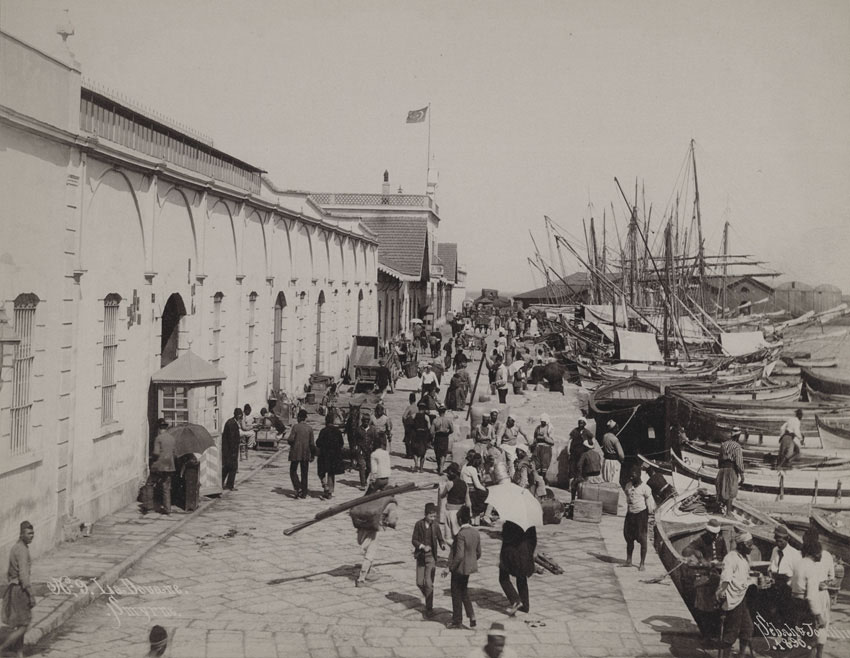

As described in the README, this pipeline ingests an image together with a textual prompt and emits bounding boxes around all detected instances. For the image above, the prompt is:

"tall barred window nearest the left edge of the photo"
[10,293,39,455]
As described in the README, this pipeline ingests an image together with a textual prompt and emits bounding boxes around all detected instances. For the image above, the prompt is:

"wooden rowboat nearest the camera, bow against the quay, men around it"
[653,489,801,637]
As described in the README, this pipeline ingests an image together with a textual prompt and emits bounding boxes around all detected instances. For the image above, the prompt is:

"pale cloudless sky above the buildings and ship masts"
[0,0,850,292]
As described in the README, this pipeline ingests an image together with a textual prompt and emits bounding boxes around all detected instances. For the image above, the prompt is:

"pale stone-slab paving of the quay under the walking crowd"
[16,336,847,658]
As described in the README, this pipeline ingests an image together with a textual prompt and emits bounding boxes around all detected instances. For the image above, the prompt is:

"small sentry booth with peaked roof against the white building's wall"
[151,350,227,496]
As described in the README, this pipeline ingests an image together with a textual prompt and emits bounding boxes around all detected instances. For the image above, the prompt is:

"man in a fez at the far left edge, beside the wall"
[0,521,35,658]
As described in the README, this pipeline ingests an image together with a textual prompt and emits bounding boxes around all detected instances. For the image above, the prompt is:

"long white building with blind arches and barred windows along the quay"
[0,33,378,564]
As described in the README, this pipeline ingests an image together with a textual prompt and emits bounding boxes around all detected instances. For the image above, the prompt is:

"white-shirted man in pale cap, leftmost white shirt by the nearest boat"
[717,532,753,658]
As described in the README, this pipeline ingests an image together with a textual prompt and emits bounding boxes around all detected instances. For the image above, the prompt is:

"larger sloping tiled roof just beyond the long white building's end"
[361,216,428,277]
